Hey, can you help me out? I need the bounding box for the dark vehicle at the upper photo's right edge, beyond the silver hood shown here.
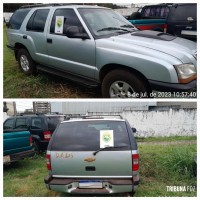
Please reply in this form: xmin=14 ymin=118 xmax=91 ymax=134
xmin=167 ymin=3 xmax=197 ymax=41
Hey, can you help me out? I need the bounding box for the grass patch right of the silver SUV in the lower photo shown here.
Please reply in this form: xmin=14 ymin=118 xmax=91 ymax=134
xmin=136 ymin=144 xmax=197 ymax=197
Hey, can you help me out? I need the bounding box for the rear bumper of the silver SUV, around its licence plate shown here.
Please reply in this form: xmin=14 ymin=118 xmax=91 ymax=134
xmin=44 ymin=176 xmax=139 ymax=194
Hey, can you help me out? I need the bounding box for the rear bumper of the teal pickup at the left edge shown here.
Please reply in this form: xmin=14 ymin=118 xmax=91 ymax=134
xmin=3 ymin=150 xmax=34 ymax=164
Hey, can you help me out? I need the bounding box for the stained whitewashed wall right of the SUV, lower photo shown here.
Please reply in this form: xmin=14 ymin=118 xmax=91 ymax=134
xmin=122 ymin=108 xmax=197 ymax=137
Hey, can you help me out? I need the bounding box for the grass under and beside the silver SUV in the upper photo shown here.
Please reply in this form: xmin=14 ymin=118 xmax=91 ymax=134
xmin=3 ymin=26 xmax=101 ymax=98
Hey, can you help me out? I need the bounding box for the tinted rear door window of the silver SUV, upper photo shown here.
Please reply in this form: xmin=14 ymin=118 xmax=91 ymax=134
xmin=26 ymin=9 xmax=49 ymax=32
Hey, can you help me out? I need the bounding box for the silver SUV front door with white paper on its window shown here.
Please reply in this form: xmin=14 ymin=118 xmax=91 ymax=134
xmin=47 ymin=8 xmax=96 ymax=78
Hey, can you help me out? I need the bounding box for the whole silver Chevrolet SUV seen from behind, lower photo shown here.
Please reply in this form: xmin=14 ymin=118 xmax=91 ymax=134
xmin=44 ymin=118 xmax=139 ymax=194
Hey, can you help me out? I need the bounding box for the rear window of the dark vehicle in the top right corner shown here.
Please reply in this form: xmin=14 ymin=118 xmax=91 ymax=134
xmin=168 ymin=4 xmax=197 ymax=21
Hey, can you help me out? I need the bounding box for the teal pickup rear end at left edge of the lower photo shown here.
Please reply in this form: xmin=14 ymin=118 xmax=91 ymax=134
xmin=3 ymin=131 xmax=34 ymax=164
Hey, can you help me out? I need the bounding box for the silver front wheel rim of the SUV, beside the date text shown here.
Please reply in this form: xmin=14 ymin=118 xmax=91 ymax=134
xmin=109 ymin=81 xmax=135 ymax=98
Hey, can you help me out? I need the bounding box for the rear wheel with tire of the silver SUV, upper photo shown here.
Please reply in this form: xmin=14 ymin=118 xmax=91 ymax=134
xmin=17 ymin=49 xmax=36 ymax=75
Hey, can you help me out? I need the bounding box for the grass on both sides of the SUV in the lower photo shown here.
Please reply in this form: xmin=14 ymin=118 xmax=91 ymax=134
xmin=3 ymin=140 xmax=197 ymax=197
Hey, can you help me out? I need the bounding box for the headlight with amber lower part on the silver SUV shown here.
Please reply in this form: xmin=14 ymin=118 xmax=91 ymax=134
xmin=174 ymin=64 xmax=197 ymax=83
